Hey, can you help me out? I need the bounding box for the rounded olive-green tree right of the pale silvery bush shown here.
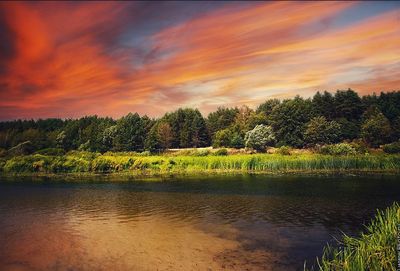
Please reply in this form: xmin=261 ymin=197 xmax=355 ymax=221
xmin=304 ymin=117 xmax=340 ymax=145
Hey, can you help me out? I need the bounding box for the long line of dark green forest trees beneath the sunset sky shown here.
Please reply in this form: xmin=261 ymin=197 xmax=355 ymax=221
xmin=0 ymin=89 xmax=400 ymax=152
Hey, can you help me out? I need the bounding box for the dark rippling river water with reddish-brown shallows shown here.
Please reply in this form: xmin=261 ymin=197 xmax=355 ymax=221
xmin=0 ymin=175 xmax=400 ymax=271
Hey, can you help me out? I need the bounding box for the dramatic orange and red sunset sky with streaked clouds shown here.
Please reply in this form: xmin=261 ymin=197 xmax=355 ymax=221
xmin=0 ymin=1 xmax=400 ymax=120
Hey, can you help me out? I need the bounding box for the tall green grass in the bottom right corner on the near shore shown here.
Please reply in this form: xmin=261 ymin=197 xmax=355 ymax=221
xmin=304 ymin=203 xmax=400 ymax=271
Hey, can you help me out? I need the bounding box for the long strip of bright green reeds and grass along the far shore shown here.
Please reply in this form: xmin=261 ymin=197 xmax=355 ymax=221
xmin=0 ymin=152 xmax=400 ymax=174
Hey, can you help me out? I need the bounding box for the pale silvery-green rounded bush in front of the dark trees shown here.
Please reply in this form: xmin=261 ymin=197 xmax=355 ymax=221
xmin=244 ymin=124 xmax=276 ymax=152
